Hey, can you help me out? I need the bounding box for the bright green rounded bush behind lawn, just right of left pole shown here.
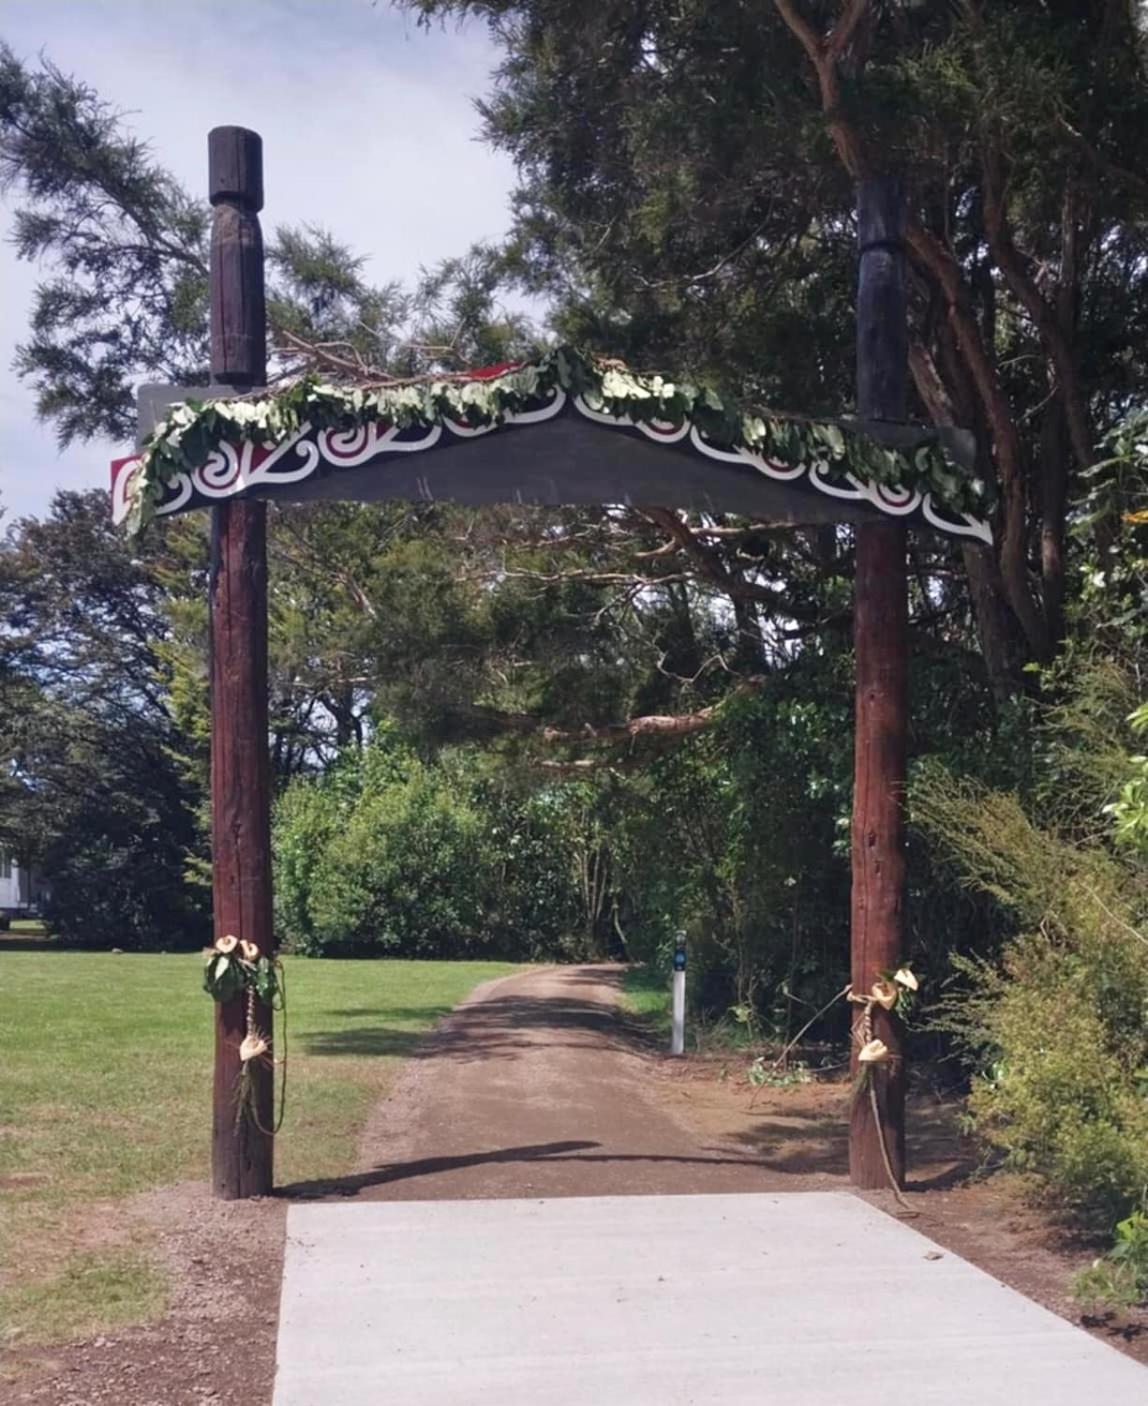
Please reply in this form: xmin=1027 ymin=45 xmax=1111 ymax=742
xmin=274 ymin=735 xmax=578 ymax=957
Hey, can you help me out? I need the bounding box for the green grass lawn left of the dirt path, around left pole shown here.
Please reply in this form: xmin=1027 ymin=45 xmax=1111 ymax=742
xmin=0 ymin=948 xmax=516 ymax=1347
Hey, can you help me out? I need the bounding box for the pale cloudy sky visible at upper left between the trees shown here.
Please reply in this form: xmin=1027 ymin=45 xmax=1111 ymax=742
xmin=0 ymin=0 xmax=514 ymax=519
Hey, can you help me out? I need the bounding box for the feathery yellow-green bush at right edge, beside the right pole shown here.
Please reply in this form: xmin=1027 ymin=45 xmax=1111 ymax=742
xmin=912 ymin=768 xmax=1148 ymax=1223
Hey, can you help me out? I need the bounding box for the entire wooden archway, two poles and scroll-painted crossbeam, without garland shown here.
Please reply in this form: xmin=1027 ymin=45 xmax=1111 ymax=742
xmin=112 ymin=127 xmax=991 ymax=1199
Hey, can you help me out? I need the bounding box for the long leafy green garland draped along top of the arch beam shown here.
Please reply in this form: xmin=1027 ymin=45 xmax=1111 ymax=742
xmin=122 ymin=347 xmax=986 ymax=530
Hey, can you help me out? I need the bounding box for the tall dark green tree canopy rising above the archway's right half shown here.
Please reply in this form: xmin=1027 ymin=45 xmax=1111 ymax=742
xmin=410 ymin=0 xmax=1148 ymax=688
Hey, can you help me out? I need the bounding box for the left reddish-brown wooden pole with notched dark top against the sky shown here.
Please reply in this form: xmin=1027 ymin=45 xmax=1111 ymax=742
xmin=208 ymin=127 xmax=274 ymax=1201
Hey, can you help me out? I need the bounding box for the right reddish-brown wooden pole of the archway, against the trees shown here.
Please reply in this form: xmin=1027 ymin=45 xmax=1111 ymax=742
xmin=849 ymin=177 xmax=909 ymax=1188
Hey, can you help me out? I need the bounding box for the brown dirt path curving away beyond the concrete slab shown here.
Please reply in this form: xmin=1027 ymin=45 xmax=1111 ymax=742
xmin=296 ymin=966 xmax=797 ymax=1201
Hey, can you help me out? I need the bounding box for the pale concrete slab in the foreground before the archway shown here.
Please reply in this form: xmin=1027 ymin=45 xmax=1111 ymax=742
xmin=274 ymin=1192 xmax=1148 ymax=1406
